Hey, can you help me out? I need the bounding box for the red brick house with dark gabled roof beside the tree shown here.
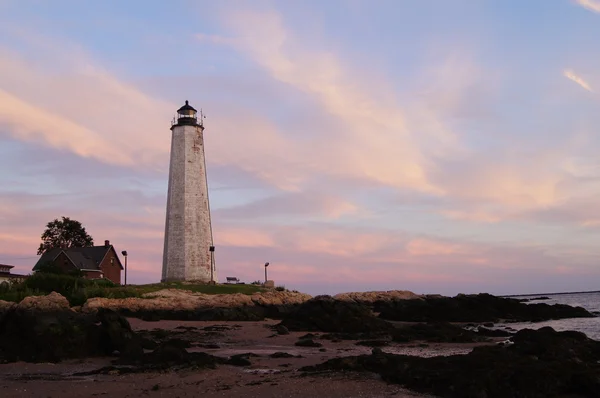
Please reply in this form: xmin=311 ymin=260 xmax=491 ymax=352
xmin=33 ymin=240 xmax=123 ymax=285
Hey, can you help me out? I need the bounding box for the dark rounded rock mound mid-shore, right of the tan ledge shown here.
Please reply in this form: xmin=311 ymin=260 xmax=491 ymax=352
xmin=280 ymin=296 xmax=393 ymax=333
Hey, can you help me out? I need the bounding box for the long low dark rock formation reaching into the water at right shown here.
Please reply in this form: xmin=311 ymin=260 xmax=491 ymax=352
xmin=379 ymin=294 xmax=594 ymax=322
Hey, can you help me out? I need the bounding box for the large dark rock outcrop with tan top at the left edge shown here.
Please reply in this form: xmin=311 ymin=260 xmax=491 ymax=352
xmin=0 ymin=293 xmax=142 ymax=362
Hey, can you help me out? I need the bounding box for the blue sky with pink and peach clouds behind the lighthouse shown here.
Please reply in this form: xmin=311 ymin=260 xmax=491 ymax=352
xmin=0 ymin=0 xmax=600 ymax=295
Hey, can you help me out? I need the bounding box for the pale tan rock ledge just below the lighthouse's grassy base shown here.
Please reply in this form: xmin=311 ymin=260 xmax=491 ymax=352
xmin=81 ymin=289 xmax=311 ymax=321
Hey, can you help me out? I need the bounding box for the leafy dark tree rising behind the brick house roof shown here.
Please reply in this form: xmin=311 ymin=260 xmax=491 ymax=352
xmin=38 ymin=216 xmax=94 ymax=254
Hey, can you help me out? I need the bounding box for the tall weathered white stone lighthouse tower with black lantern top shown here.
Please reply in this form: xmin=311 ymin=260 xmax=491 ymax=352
xmin=162 ymin=101 xmax=217 ymax=282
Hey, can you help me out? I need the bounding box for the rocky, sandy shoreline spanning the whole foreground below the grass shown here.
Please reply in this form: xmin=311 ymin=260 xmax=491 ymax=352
xmin=0 ymin=290 xmax=600 ymax=398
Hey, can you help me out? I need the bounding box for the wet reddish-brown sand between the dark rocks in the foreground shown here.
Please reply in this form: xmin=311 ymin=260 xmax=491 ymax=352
xmin=0 ymin=318 xmax=492 ymax=398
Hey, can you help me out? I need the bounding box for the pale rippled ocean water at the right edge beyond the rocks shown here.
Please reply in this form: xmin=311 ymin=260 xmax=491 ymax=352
xmin=496 ymin=292 xmax=600 ymax=340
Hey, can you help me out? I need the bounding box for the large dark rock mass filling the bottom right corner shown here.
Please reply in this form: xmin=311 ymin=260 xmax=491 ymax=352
xmin=301 ymin=327 xmax=600 ymax=398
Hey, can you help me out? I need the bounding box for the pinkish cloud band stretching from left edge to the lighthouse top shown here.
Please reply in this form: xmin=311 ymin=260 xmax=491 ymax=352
xmin=0 ymin=43 xmax=177 ymax=169
